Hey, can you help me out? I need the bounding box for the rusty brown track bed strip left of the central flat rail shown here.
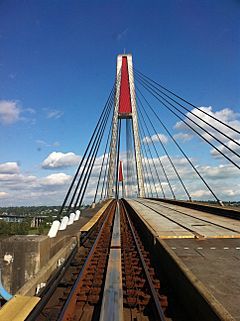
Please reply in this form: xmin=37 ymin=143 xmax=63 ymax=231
xmin=58 ymin=202 xmax=116 ymax=321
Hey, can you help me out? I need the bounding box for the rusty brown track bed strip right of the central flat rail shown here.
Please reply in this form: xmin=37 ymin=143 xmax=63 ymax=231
xmin=120 ymin=202 xmax=168 ymax=321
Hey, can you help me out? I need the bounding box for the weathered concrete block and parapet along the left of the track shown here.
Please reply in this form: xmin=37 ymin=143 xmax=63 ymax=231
xmin=0 ymin=202 xmax=107 ymax=294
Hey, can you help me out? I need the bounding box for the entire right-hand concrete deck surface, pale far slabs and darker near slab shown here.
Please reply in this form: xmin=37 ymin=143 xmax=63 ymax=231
xmin=128 ymin=199 xmax=240 ymax=321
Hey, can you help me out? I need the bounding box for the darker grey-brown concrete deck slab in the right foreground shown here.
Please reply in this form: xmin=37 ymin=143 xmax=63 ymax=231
xmin=165 ymin=239 xmax=240 ymax=321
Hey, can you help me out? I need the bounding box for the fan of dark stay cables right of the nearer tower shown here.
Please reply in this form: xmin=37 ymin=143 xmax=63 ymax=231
xmin=131 ymin=68 xmax=240 ymax=204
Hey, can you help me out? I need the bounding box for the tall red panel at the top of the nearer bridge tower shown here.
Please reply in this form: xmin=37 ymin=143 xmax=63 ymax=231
xmin=119 ymin=56 xmax=132 ymax=114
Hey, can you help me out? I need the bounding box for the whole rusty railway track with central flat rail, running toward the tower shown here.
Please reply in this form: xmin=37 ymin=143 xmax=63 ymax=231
xmin=27 ymin=200 xmax=174 ymax=321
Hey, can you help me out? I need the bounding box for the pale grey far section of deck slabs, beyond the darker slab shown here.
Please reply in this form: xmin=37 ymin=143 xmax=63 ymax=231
xmin=128 ymin=199 xmax=240 ymax=239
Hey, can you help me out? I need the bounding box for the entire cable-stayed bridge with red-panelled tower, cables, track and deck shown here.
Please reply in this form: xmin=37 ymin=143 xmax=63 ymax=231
xmin=0 ymin=54 xmax=240 ymax=321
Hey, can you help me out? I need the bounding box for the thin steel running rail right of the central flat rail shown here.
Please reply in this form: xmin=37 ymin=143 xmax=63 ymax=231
xmin=121 ymin=201 xmax=166 ymax=321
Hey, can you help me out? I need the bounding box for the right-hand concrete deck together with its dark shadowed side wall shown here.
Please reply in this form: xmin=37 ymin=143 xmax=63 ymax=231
xmin=125 ymin=200 xmax=240 ymax=321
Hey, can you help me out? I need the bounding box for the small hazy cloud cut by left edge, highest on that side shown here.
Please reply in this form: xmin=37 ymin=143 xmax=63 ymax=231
xmin=0 ymin=100 xmax=21 ymax=125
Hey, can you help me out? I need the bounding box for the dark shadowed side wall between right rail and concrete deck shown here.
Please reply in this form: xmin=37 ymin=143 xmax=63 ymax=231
xmin=124 ymin=203 xmax=234 ymax=321
